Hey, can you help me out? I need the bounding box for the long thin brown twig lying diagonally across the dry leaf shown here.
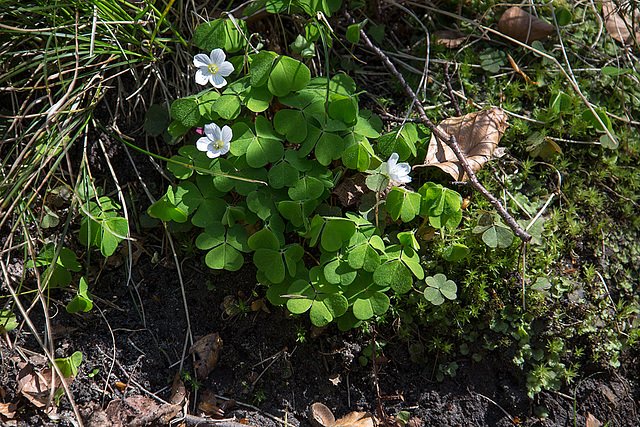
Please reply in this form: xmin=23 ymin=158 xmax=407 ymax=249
xmin=344 ymin=11 xmax=531 ymax=242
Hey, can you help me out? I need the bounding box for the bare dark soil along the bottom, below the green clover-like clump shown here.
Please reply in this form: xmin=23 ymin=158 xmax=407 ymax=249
xmin=1 ymin=252 xmax=640 ymax=427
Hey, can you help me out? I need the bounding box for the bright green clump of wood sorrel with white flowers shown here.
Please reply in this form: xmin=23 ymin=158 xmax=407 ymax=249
xmin=149 ymin=16 xmax=468 ymax=329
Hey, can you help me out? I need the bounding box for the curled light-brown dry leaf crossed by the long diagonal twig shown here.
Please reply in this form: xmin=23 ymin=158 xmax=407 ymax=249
xmin=424 ymin=107 xmax=508 ymax=181
